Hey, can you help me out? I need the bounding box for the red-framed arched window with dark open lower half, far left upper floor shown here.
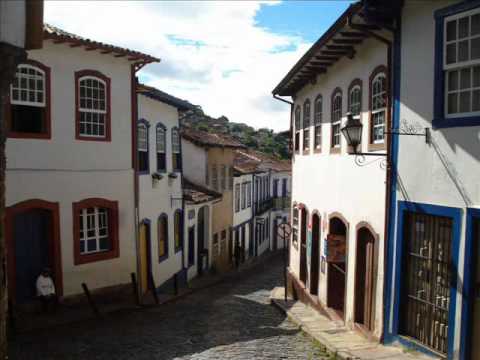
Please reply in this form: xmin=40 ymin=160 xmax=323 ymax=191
xmin=7 ymin=60 xmax=51 ymax=139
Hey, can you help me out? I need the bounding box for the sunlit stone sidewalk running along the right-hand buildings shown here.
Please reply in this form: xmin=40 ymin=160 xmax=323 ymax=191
xmin=270 ymin=287 xmax=436 ymax=360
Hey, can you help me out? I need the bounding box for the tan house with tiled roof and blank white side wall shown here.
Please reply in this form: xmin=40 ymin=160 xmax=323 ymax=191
xmin=182 ymin=129 xmax=245 ymax=271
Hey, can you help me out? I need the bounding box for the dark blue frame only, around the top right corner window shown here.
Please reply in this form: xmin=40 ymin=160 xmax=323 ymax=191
xmin=432 ymin=0 xmax=480 ymax=129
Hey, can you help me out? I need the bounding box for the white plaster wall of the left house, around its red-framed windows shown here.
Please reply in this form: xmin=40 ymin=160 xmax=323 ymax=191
xmin=6 ymin=41 xmax=136 ymax=296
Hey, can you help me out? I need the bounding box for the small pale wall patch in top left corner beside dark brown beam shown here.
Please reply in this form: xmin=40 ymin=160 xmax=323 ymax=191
xmin=0 ymin=0 xmax=26 ymax=48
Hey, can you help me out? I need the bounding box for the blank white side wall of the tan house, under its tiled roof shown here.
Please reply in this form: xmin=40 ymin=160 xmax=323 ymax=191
xmin=182 ymin=138 xmax=207 ymax=185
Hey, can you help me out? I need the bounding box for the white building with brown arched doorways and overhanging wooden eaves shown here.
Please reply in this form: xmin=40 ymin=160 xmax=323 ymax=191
xmin=273 ymin=3 xmax=389 ymax=339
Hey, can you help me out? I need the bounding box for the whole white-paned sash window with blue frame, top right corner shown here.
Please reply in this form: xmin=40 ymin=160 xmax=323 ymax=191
xmin=432 ymin=0 xmax=480 ymax=128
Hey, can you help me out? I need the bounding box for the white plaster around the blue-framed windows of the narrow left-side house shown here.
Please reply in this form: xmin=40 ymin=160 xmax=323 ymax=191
xmin=138 ymin=95 xmax=188 ymax=286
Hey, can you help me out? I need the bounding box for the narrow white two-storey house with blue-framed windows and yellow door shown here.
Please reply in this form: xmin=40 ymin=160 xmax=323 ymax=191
xmin=137 ymin=85 xmax=192 ymax=294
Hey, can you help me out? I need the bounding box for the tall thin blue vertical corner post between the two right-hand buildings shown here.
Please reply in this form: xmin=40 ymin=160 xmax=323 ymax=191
xmin=383 ymin=11 xmax=402 ymax=342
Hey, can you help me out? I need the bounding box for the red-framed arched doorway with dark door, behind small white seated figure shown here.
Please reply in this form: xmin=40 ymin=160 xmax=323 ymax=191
xmin=5 ymin=199 xmax=63 ymax=304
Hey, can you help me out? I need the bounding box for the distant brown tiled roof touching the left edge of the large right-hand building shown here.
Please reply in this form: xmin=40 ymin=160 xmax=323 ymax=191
xmin=233 ymin=149 xmax=292 ymax=174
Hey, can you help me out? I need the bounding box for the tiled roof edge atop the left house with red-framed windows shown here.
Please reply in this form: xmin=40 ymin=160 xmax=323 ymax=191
xmin=43 ymin=24 xmax=160 ymax=64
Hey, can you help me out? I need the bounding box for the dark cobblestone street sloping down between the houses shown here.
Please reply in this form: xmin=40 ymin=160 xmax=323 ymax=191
xmin=10 ymin=257 xmax=328 ymax=359
